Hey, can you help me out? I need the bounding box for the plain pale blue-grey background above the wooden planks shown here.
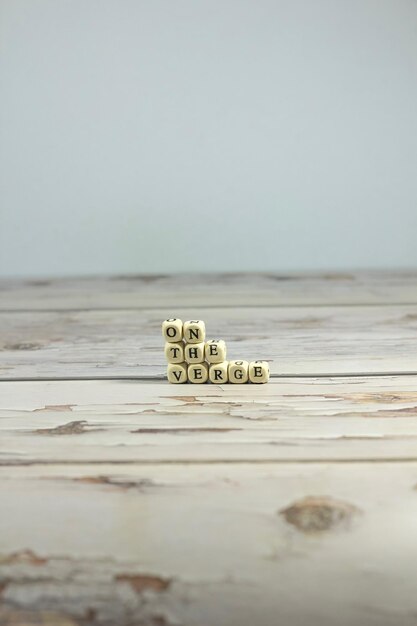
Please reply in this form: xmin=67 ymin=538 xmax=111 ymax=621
xmin=0 ymin=0 xmax=417 ymax=275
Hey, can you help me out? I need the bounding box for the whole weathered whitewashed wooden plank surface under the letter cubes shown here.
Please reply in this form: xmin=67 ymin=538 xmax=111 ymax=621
xmin=0 ymin=272 xmax=417 ymax=626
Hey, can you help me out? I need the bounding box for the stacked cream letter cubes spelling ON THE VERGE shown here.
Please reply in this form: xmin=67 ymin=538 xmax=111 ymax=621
xmin=162 ymin=318 xmax=269 ymax=384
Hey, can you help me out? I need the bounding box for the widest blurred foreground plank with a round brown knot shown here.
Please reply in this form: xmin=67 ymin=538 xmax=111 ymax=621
xmin=0 ymin=463 xmax=417 ymax=626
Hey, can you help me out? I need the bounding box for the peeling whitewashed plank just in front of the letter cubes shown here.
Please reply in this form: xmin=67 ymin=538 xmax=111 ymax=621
xmin=0 ymin=376 xmax=417 ymax=464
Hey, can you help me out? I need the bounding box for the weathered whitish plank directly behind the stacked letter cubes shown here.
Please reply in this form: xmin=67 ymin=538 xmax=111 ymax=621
xmin=0 ymin=305 xmax=417 ymax=379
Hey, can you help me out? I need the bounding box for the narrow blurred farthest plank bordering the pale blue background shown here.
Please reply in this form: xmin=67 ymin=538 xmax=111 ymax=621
xmin=0 ymin=271 xmax=417 ymax=310
